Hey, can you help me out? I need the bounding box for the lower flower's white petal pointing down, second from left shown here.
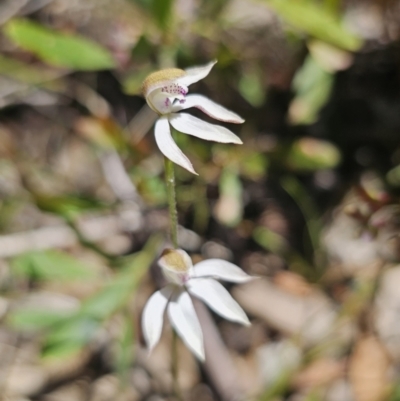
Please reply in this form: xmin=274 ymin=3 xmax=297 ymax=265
xmin=168 ymin=291 xmax=205 ymax=361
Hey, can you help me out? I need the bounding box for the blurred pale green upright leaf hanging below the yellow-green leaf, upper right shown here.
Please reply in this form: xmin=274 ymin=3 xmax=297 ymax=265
xmin=289 ymin=56 xmax=333 ymax=124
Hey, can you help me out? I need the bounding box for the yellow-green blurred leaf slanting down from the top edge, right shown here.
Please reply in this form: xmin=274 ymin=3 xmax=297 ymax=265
xmin=263 ymin=0 xmax=362 ymax=51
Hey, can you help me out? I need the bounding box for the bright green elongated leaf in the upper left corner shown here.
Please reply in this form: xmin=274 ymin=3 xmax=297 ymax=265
xmin=4 ymin=19 xmax=115 ymax=70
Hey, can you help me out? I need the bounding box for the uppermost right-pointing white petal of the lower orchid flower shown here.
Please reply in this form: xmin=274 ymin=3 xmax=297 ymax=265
xmin=189 ymin=259 xmax=255 ymax=283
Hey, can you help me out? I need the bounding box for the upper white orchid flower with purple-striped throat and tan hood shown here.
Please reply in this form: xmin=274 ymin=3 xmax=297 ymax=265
xmin=142 ymin=61 xmax=244 ymax=174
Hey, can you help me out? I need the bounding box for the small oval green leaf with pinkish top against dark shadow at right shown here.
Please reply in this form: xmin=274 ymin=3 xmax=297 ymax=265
xmin=286 ymin=137 xmax=340 ymax=171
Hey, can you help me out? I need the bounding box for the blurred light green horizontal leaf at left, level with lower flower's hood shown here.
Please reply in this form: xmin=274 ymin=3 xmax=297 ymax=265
xmin=11 ymin=250 xmax=94 ymax=281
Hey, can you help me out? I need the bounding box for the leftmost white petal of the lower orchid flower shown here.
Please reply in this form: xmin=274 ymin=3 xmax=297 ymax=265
xmin=142 ymin=286 xmax=173 ymax=351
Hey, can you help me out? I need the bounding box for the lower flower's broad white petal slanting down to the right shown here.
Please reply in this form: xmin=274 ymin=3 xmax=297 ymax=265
xmin=187 ymin=278 xmax=250 ymax=326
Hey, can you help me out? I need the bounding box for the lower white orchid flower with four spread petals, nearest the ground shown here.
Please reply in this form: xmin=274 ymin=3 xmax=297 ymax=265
xmin=142 ymin=249 xmax=254 ymax=361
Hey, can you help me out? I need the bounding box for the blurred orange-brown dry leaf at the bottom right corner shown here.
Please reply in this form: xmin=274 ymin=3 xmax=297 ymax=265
xmin=349 ymin=335 xmax=390 ymax=401
